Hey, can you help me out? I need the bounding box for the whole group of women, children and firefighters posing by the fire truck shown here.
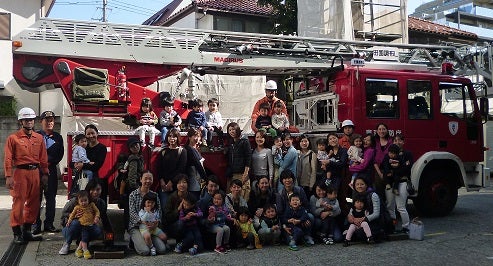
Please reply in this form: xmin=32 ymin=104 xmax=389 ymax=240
xmin=5 ymin=81 xmax=413 ymax=259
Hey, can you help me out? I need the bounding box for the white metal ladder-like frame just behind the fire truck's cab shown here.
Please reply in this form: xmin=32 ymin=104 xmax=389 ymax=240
xmin=293 ymin=92 xmax=339 ymax=132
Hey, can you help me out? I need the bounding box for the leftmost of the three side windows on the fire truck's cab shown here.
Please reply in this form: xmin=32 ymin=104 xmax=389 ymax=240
xmin=366 ymin=79 xmax=399 ymax=118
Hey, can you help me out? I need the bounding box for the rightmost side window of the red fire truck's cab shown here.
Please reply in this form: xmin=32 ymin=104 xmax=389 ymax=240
xmin=439 ymin=82 xmax=474 ymax=119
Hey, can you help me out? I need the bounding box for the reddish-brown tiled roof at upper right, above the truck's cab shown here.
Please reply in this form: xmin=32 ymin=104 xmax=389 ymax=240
xmin=408 ymin=16 xmax=478 ymax=39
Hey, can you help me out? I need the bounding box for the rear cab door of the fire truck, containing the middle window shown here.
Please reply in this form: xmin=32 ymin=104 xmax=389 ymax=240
xmin=401 ymin=79 xmax=438 ymax=158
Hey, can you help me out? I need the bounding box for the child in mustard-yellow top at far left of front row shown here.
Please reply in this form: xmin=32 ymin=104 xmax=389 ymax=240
xmin=66 ymin=190 xmax=100 ymax=259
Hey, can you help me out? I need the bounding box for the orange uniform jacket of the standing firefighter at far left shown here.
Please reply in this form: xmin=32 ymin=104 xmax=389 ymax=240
xmin=3 ymin=129 xmax=48 ymax=177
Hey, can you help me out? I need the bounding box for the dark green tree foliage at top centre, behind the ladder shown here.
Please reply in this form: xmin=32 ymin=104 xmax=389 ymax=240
xmin=258 ymin=0 xmax=298 ymax=35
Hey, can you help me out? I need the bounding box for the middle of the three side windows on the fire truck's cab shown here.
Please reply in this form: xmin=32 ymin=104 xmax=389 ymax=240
xmin=407 ymin=80 xmax=432 ymax=120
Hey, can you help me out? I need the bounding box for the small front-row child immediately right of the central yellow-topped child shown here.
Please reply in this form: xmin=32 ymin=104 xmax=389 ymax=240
xmin=254 ymin=204 xmax=281 ymax=245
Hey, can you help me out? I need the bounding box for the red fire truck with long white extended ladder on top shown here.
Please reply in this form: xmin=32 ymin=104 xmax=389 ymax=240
xmin=13 ymin=19 xmax=488 ymax=218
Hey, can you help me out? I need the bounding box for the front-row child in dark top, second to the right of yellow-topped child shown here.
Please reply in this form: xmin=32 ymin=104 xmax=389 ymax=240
xmin=282 ymin=193 xmax=315 ymax=251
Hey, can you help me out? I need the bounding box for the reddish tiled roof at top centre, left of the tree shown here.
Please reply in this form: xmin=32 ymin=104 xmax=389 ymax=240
xmin=195 ymin=0 xmax=273 ymax=15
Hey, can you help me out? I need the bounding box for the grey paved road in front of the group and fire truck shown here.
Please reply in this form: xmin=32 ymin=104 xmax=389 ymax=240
xmin=0 ymin=182 xmax=493 ymax=266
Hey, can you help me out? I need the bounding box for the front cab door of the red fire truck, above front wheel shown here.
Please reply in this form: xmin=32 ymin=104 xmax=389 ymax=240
xmin=435 ymin=82 xmax=483 ymax=162
